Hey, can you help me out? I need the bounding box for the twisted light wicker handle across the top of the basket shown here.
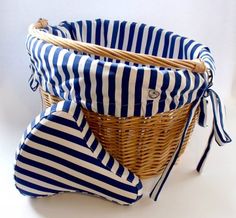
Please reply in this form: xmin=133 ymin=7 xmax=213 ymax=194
xmin=29 ymin=19 xmax=206 ymax=73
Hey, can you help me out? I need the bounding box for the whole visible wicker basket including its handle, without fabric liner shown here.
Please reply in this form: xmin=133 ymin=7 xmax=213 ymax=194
xmin=30 ymin=20 xmax=206 ymax=178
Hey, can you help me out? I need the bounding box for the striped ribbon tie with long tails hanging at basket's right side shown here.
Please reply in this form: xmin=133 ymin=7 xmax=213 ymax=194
xmin=150 ymin=88 xmax=231 ymax=201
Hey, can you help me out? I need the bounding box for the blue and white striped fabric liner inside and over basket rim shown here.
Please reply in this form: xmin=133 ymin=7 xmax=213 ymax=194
xmin=27 ymin=19 xmax=215 ymax=117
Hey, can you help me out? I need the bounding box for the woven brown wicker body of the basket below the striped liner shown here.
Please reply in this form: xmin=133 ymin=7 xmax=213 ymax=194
xmin=40 ymin=89 xmax=199 ymax=178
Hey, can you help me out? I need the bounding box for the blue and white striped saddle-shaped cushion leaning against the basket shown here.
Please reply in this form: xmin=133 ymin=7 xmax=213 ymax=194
xmin=15 ymin=101 xmax=142 ymax=204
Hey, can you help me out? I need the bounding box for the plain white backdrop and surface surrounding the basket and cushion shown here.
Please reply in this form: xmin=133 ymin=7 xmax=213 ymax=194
xmin=0 ymin=0 xmax=236 ymax=218
